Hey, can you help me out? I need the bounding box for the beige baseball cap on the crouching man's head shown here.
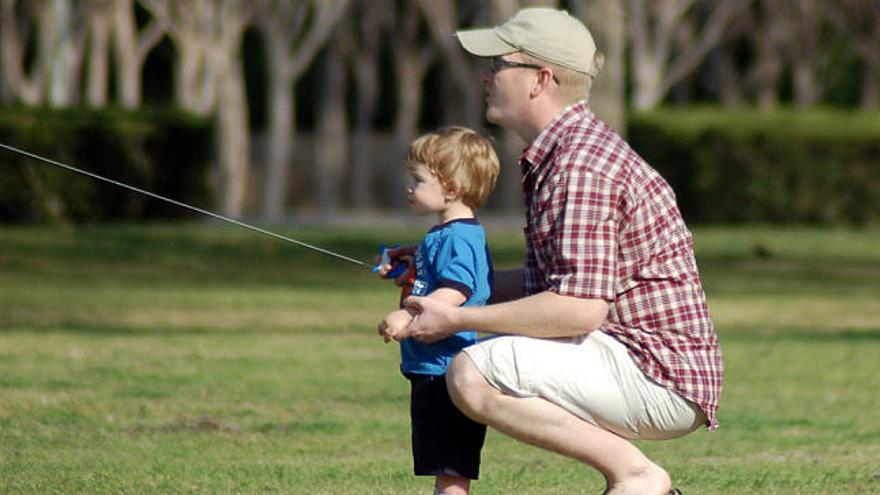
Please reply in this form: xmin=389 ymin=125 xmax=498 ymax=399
xmin=455 ymin=7 xmax=599 ymax=76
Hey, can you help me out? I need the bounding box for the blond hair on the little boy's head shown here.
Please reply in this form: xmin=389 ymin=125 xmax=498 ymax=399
xmin=406 ymin=126 xmax=500 ymax=210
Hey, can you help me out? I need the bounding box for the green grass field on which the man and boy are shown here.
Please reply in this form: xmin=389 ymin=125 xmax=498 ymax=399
xmin=0 ymin=223 xmax=880 ymax=495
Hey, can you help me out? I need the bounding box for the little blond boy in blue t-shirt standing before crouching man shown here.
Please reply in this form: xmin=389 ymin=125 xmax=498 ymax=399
xmin=379 ymin=127 xmax=499 ymax=495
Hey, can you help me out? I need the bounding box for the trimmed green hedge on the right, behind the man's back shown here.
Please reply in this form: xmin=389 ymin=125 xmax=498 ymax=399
xmin=628 ymin=108 xmax=880 ymax=225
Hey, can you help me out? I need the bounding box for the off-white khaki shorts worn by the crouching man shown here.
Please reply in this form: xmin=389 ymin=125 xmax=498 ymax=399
xmin=464 ymin=331 xmax=706 ymax=439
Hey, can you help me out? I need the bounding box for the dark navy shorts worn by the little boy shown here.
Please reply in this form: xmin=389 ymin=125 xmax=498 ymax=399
xmin=406 ymin=374 xmax=486 ymax=480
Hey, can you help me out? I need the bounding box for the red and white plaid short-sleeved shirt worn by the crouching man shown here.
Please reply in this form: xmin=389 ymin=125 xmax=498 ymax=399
xmin=520 ymin=102 xmax=723 ymax=429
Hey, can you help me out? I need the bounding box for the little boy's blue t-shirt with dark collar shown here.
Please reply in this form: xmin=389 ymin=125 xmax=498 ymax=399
xmin=400 ymin=218 xmax=492 ymax=375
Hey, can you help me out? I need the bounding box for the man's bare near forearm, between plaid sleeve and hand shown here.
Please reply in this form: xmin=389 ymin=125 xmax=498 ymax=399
xmin=458 ymin=292 xmax=609 ymax=337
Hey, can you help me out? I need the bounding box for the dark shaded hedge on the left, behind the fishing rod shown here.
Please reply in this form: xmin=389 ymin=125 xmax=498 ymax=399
xmin=0 ymin=108 xmax=213 ymax=222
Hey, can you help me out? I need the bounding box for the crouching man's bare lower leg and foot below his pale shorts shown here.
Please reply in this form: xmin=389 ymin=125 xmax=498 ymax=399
xmin=446 ymin=353 xmax=671 ymax=495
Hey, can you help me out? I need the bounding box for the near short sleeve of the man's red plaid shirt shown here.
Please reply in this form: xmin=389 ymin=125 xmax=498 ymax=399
xmin=545 ymin=157 xmax=618 ymax=302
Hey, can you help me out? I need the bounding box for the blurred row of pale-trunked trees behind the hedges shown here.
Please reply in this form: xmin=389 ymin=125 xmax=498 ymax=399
xmin=0 ymin=0 xmax=880 ymax=222
